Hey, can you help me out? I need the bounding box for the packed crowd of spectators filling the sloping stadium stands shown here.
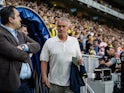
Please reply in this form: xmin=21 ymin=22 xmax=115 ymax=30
xmin=6 ymin=0 xmax=124 ymax=68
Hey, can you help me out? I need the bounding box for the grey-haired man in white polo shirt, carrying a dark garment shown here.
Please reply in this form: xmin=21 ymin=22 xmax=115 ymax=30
xmin=40 ymin=18 xmax=82 ymax=93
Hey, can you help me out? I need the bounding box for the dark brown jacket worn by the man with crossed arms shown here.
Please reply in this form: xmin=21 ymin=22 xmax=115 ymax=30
xmin=0 ymin=26 xmax=40 ymax=92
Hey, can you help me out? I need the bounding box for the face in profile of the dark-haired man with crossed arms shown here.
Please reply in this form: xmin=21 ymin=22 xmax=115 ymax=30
xmin=12 ymin=9 xmax=21 ymax=29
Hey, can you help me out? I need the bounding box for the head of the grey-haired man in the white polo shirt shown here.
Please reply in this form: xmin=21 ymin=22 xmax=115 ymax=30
xmin=57 ymin=20 xmax=69 ymax=36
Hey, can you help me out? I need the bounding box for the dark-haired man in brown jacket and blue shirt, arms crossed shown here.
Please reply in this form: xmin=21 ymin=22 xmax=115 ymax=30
xmin=0 ymin=6 xmax=40 ymax=93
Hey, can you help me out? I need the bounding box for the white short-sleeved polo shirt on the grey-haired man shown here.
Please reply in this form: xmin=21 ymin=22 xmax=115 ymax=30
xmin=40 ymin=36 xmax=82 ymax=86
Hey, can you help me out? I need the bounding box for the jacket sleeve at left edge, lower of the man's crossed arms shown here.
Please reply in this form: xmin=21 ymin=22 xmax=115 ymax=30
xmin=0 ymin=33 xmax=28 ymax=61
